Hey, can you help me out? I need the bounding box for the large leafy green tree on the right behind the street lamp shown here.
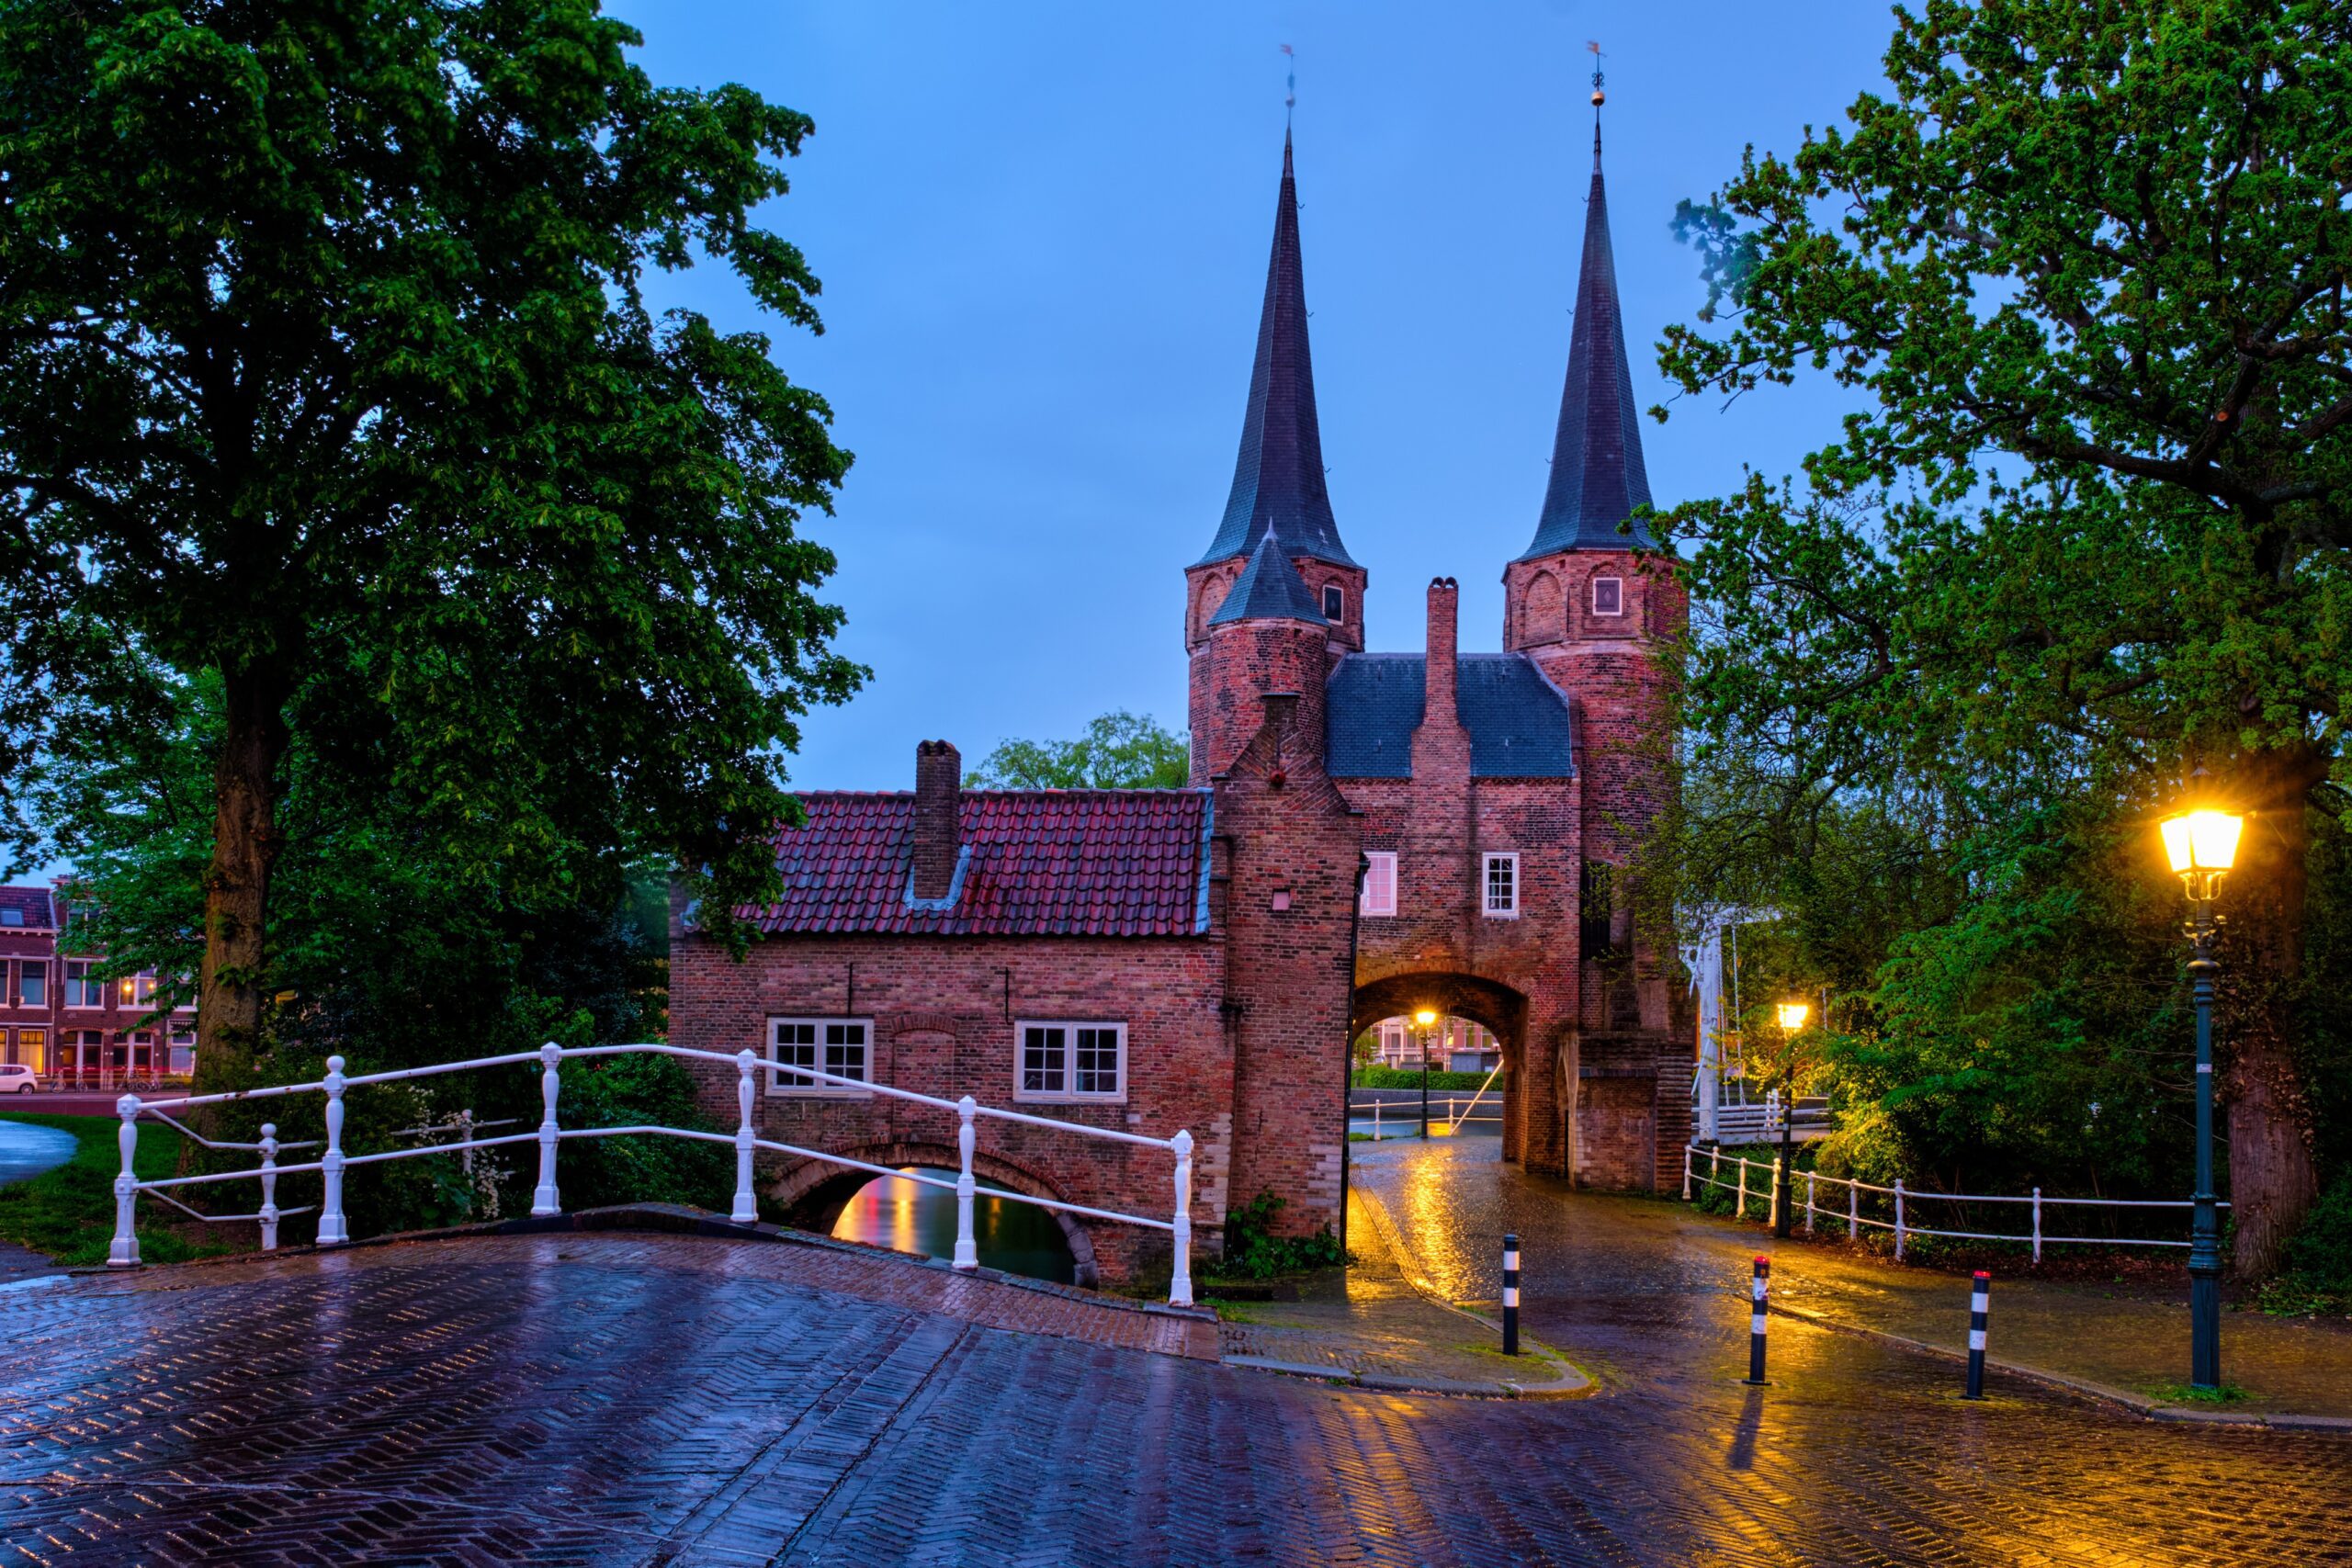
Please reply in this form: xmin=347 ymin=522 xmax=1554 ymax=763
xmin=1663 ymin=0 xmax=2352 ymax=1269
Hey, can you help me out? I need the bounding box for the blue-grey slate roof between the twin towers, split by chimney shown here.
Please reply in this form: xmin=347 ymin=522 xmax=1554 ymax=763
xmin=1324 ymin=653 xmax=1576 ymax=778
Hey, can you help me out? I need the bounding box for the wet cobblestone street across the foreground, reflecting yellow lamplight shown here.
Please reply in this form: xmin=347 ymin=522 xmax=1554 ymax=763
xmin=0 ymin=1203 xmax=2352 ymax=1568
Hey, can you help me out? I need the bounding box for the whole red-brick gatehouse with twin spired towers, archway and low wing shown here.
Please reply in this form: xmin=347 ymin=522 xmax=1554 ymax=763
xmin=671 ymin=122 xmax=1691 ymax=1277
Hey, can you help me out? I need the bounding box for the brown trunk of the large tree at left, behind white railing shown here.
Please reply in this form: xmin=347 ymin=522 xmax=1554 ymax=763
xmin=195 ymin=665 xmax=287 ymax=1093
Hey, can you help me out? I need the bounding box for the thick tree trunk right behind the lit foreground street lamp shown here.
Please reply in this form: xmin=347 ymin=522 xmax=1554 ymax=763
xmin=2216 ymin=748 xmax=2326 ymax=1279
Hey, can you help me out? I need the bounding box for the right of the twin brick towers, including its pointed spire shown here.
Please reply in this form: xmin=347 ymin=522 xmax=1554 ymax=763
xmin=1503 ymin=125 xmax=1687 ymax=1030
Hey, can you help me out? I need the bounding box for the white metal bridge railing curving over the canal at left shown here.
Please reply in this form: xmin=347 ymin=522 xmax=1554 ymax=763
xmin=106 ymin=1043 xmax=1193 ymax=1307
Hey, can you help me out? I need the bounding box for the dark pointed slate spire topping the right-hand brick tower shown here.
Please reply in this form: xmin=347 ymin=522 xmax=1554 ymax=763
xmin=1520 ymin=125 xmax=1654 ymax=559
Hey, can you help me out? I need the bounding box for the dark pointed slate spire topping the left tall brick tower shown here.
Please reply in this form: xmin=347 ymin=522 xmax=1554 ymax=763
xmin=1194 ymin=131 xmax=1355 ymax=567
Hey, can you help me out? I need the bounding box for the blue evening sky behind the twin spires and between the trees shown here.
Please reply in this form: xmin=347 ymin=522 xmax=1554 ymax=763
xmin=614 ymin=0 xmax=1894 ymax=790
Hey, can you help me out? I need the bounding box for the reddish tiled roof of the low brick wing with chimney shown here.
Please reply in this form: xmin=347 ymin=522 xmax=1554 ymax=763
xmin=736 ymin=790 xmax=1211 ymax=936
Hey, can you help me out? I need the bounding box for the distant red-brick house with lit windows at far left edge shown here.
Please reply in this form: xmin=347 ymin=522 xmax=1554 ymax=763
xmin=0 ymin=884 xmax=195 ymax=1086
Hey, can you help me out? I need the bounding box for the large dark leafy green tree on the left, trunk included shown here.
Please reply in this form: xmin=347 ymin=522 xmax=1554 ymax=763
xmin=0 ymin=0 xmax=861 ymax=1081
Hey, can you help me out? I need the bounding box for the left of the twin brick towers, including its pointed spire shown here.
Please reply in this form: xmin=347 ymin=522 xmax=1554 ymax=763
xmin=1183 ymin=131 xmax=1364 ymax=785
